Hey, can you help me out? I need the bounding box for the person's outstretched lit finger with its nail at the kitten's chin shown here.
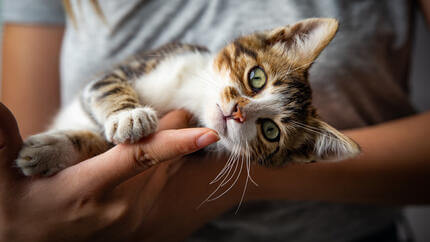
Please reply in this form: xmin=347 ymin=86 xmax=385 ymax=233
xmin=69 ymin=128 xmax=219 ymax=191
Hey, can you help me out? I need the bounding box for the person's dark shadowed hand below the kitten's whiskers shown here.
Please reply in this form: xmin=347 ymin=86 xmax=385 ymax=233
xmin=134 ymin=152 xmax=244 ymax=241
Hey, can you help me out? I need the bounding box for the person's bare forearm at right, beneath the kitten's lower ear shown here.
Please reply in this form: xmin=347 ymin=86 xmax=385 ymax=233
xmin=249 ymin=113 xmax=430 ymax=205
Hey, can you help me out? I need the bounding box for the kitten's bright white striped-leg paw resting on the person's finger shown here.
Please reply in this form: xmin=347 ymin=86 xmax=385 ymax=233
xmin=105 ymin=107 xmax=158 ymax=144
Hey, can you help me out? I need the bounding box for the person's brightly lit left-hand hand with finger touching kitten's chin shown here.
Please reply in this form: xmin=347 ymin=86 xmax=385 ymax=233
xmin=0 ymin=104 xmax=218 ymax=241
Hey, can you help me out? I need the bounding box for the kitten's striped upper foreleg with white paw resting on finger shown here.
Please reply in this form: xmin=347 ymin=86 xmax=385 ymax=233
xmin=81 ymin=72 xmax=158 ymax=143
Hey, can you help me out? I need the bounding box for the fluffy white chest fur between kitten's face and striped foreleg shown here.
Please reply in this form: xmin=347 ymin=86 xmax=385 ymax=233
xmin=134 ymin=53 xmax=213 ymax=116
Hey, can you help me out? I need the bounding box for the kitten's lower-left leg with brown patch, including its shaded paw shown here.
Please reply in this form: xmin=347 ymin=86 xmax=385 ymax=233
xmin=16 ymin=130 xmax=111 ymax=176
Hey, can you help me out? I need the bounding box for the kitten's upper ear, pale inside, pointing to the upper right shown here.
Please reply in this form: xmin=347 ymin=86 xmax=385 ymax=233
xmin=267 ymin=18 xmax=339 ymax=68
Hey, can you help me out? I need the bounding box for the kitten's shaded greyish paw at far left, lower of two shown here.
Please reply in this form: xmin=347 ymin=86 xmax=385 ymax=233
xmin=15 ymin=133 xmax=76 ymax=176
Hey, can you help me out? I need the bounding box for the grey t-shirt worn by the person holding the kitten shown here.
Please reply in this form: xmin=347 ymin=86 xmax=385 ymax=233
xmin=3 ymin=0 xmax=414 ymax=241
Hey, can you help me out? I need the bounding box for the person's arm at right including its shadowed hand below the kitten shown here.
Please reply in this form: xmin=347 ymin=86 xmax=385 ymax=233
xmin=134 ymin=112 xmax=430 ymax=241
